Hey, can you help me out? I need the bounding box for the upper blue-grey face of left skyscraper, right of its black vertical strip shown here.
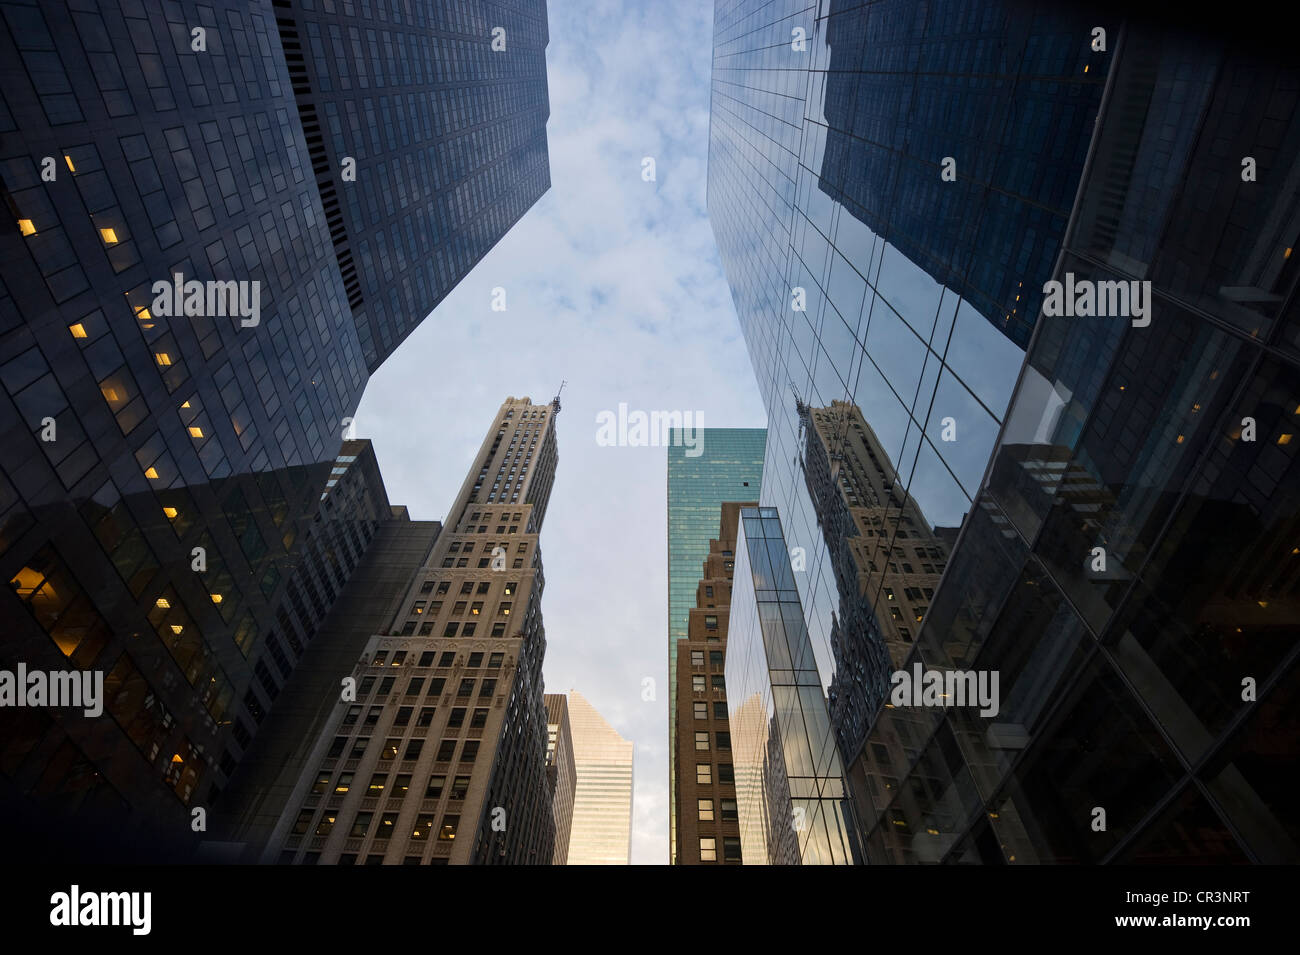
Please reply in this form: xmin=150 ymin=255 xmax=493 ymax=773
xmin=272 ymin=0 xmax=551 ymax=372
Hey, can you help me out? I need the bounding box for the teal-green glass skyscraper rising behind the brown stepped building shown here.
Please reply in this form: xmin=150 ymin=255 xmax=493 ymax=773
xmin=668 ymin=427 xmax=767 ymax=856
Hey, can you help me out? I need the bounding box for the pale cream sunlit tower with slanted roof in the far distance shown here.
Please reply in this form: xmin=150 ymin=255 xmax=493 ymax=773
xmin=568 ymin=690 xmax=634 ymax=865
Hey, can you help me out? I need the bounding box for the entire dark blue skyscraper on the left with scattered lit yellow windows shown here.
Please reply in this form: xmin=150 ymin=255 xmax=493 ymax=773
xmin=0 ymin=0 xmax=547 ymax=855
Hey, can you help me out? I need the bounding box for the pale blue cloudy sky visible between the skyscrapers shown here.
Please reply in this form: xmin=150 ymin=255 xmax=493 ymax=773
xmin=356 ymin=0 xmax=766 ymax=864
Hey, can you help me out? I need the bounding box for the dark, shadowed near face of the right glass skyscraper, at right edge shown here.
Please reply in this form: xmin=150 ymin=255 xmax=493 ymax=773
xmin=859 ymin=29 xmax=1300 ymax=864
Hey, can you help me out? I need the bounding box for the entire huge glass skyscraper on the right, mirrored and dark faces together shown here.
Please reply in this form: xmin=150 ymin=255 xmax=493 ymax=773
xmin=709 ymin=0 xmax=1300 ymax=863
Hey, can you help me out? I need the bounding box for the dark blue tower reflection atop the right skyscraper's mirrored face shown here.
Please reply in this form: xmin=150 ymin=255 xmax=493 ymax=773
xmin=803 ymin=0 xmax=1115 ymax=348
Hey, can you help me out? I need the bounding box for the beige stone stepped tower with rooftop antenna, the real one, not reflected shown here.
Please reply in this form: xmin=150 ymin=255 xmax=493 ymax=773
xmin=268 ymin=398 xmax=561 ymax=865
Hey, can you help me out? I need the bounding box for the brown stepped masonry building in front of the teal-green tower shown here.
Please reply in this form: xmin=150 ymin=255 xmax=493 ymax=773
xmin=672 ymin=504 xmax=754 ymax=865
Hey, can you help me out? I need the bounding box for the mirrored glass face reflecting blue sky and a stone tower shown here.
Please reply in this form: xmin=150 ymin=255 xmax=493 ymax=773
xmin=709 ymin=0 xmax=1113 ymax=860
